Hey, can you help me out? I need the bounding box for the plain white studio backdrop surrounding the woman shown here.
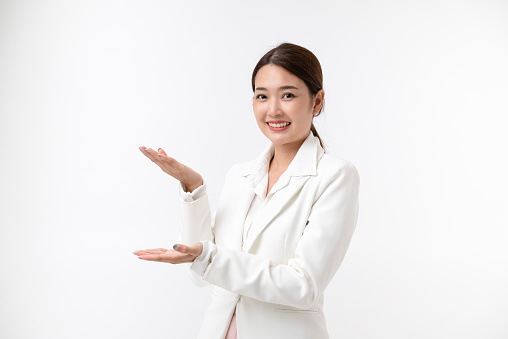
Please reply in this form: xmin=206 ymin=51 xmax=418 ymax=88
xmin=0 ymin=0 xmax=508 ymax=339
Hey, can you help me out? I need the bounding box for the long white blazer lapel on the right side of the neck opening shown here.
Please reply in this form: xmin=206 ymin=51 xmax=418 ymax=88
xmin=243 ymin=175 xmax=310 ymax=252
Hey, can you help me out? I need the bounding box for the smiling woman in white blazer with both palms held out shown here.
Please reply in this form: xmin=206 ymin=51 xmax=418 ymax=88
xmin=134 ymin=43 xmax=359 ymax=339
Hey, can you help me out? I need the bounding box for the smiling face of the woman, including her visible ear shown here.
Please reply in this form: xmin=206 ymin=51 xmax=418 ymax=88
xmin=252 ymin=64 xmax=324 ymax=147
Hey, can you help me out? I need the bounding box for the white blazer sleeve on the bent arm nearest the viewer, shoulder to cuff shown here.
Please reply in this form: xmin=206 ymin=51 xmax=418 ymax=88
xmin=196 ymin=163 xmax=359 ymax=309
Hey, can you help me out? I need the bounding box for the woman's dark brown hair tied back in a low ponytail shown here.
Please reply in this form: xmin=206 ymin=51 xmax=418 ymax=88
xmin=252 ymin=42 xmax=324 ymax=148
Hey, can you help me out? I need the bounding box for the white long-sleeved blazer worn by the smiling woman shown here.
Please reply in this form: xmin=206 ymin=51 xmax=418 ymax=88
xmin=180 ymin=133 xmax=359 ymax=339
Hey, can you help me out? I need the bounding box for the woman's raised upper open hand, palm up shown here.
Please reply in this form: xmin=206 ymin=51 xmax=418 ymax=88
xmin=139 ymin=146 xmax=203 ymax=192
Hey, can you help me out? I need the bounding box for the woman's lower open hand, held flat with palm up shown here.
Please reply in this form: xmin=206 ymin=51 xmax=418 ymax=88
xmin=134 ymin=242 xmax=203 ymax=264
